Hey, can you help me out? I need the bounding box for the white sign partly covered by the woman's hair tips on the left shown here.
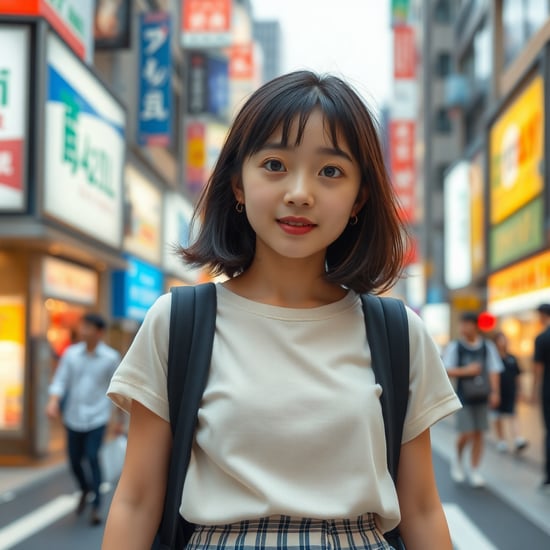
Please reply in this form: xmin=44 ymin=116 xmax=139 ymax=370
xmin=162 ymin=192 xmax=199 ymax=283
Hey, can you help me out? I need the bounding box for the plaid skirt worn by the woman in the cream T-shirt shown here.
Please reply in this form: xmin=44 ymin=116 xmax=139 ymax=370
xmin=186 ymin=514 xmax=391 ymax=550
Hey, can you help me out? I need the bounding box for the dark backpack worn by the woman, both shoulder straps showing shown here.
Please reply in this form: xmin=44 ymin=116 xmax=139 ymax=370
xmin=152 ymin=283 xmax=409 ymax=550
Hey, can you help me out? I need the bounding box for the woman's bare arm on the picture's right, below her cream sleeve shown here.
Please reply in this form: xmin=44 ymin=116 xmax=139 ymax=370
xmin=397 ymin=430 xmax=452 ymax=550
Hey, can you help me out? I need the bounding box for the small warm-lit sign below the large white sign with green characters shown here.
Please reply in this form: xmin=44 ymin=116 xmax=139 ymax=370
xmin=42 ymin=257 xmax=98 ymax=306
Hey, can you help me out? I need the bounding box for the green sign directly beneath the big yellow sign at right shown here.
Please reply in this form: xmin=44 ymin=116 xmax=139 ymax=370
xmin=489 ymin=196 xmax=544 ymax=270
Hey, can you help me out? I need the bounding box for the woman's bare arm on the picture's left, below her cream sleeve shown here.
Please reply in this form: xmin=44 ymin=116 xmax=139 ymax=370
xmin=101 ymin=401 xmax=172 ymax=550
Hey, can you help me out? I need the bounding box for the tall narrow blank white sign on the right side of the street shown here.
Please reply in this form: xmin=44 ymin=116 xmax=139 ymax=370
xmin=444 ymin=161 xmax=472 ymax=289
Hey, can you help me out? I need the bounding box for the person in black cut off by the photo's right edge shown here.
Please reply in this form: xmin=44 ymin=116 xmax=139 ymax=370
xmin=534 ymin=304 xmax=550 ymax=494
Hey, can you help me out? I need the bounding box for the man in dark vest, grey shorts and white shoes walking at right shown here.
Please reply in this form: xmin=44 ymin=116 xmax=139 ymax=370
xmin=443 ymin=312 xmax=503 ymax=487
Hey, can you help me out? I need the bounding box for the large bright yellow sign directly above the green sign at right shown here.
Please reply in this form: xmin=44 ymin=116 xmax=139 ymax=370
xmin=489 ymin=76 xmax=544 ymax=224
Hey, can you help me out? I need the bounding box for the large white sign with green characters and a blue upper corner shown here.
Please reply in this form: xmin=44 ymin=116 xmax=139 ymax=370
xmin=44 ymin=34 xmax=126 ymax=248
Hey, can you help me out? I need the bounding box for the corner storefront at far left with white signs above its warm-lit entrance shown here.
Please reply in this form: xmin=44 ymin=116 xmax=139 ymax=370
xmin=0 ymin=20 xmax=126 ymax=461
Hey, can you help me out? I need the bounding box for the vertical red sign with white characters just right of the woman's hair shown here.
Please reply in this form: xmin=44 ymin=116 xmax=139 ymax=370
xmin=390 ymin=120 xmax=416 ymax=222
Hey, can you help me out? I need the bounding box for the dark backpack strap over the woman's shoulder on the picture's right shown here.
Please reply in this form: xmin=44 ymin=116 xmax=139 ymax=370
xmin=361 ymin=294 xmax=410 ymax=549
